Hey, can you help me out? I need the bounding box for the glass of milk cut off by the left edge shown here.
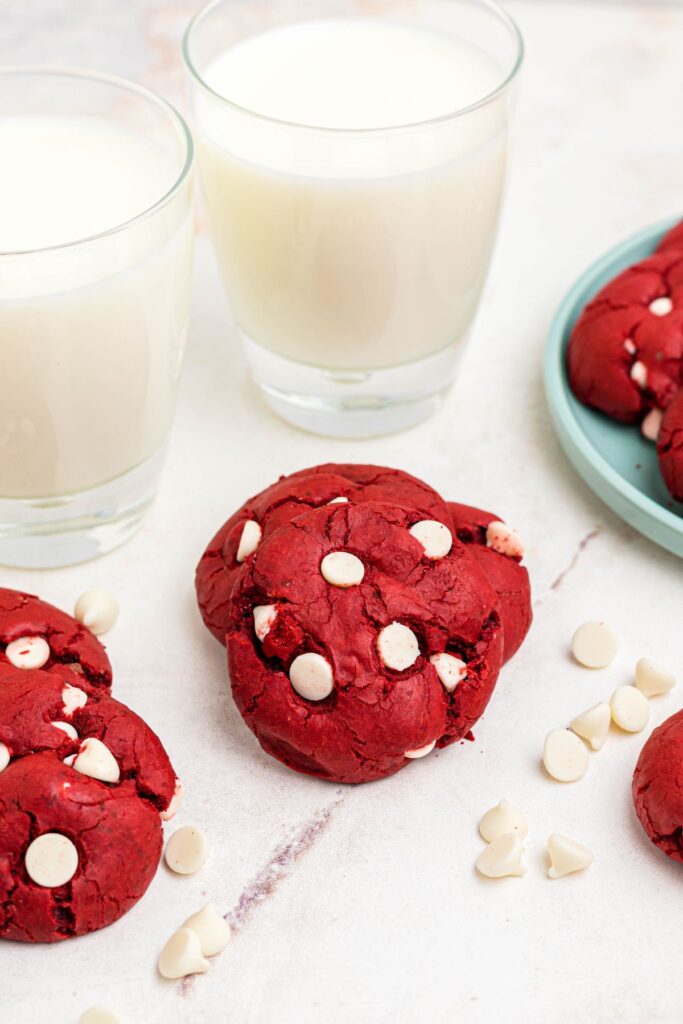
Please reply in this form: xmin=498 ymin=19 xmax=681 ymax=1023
xmin=0 ymin=68 xmax=194 ymax=567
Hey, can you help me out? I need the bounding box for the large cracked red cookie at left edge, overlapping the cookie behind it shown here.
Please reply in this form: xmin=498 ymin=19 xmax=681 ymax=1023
xmin=0 ymin=665 xmax=177 ymax=942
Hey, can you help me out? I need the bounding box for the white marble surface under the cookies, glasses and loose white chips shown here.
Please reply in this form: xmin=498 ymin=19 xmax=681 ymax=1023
xmin=0 ymin=0 xmax=683 ymax=1024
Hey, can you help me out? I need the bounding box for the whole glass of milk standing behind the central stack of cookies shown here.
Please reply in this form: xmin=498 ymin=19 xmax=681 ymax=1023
xmin=184 ymin=0 xmax=522 ymax=437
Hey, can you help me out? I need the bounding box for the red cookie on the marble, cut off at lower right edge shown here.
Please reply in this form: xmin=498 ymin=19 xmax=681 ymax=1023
xmin=633 ymin=711 xmax=683 ymax=863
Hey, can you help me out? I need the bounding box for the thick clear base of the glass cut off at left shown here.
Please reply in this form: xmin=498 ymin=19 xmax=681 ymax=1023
xmin=0 ymin=444 xmax=166 ymax=569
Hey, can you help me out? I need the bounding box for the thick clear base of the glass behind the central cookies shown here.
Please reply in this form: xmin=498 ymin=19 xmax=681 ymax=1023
xmin=242 ymin=334 xmax=464 ymax=437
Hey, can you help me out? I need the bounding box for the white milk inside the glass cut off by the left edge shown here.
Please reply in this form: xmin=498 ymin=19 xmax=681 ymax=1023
xmin=0 ymin=115 xmax=193 ymax=499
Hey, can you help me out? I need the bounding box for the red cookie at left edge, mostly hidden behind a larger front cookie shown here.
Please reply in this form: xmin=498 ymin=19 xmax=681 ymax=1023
xmin=0 ymin=588 xmax=112 ymax=692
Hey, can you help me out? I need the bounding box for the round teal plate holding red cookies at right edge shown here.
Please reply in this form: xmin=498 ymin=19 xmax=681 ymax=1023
xmin=545 ymin=221 xmax=683 ymax=558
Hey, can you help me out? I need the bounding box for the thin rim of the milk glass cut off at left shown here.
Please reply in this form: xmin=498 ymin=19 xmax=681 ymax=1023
xmin=0 ymin=65 xmax=195 ymax=259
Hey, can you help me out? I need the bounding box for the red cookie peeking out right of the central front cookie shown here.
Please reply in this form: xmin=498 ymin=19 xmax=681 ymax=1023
xmin=449 ymin=502 xmax=532 ymax=662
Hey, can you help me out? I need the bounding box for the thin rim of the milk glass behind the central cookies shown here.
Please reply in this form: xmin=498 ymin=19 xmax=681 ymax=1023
xmin=182 ymin=0 xmax=524 ymax=136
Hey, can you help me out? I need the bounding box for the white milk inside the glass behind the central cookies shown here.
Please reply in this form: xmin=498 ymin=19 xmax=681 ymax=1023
xmin=196 ymin=18 xmax=507 ymax=372
